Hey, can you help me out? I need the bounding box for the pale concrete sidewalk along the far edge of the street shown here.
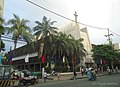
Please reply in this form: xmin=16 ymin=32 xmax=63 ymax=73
xmin=8 ymin=71 xmax=120 ymax=87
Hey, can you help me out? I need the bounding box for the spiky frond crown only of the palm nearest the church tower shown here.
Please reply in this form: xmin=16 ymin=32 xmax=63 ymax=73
xmin=33 ymin=16 xmax=57 ymax=39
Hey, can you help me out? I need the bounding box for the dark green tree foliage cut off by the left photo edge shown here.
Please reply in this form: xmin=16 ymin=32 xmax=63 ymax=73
xmin=0 ymin=17 xmax=5 ymax=52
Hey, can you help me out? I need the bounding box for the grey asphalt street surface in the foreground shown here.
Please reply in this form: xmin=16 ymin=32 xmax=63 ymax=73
xmin=25 ymin=74 xmax=120 ymax=87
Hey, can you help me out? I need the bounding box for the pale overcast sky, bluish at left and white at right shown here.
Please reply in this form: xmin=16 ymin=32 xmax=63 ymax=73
xmin=4 ymin=0 xmax=120 ymax=50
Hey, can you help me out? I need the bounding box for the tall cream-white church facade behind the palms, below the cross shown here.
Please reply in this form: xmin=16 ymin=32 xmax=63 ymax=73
xmin=59 ymin=23 xmax=93 ymax=66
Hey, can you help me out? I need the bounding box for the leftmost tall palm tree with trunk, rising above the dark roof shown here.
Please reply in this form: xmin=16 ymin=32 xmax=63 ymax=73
xmin=7 ymin=14 xmax=33 ymax=50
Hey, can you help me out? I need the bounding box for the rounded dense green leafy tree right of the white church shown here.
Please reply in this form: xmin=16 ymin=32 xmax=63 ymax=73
xmin=92 ymin=44 xmax=119 ymax=65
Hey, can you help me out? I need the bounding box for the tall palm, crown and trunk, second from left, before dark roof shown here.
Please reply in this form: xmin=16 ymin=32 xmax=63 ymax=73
xmin=33 ymin=16 xmax=58 ymax=58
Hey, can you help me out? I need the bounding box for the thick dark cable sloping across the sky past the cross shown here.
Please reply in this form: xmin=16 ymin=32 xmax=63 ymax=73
xmin=26 ymin=0 xmax=107 ymax=30
